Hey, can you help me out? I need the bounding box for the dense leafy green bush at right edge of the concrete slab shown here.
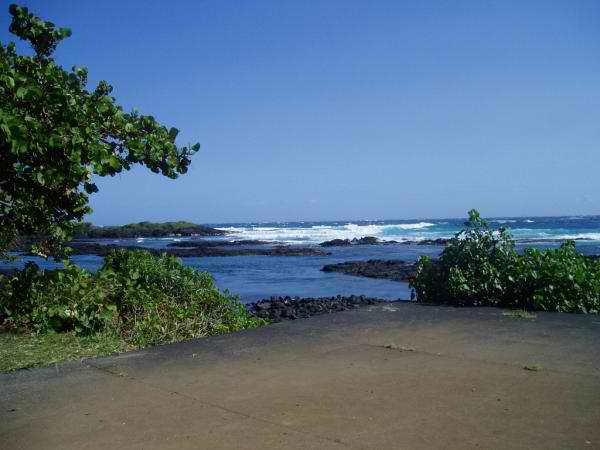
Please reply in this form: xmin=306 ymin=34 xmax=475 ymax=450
xmin=411 ymin=210 xmax=600 ymax=313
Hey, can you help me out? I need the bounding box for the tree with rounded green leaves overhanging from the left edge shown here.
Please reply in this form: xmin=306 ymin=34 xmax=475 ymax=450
xmin=0 ymin=5 xmax=200 ymax=256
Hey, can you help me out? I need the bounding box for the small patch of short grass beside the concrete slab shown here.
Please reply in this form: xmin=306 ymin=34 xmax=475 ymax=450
xmin=0 ymin=329 xmax=128 ymax=372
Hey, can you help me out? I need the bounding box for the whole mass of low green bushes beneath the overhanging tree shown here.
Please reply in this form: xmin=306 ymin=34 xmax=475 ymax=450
xmin=0 ymin=250 xmax=264 ymax=346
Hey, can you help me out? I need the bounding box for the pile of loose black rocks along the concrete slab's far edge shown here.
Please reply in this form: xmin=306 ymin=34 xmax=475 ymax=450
xmin=247 ymin=295 xmax=389 ymax=322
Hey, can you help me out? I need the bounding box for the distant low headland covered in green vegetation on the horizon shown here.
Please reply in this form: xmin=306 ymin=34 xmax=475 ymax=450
xmin=73 ymin=221 xmax=225 ymax=239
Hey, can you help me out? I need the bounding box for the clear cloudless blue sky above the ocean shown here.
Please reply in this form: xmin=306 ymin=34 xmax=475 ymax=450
xmin=0 ymin=0 xmax=600 ymax=225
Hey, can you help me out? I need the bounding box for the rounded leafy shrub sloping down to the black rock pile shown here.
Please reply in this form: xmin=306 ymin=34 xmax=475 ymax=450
xmin=101 ymin=250 xmax=264 ymax=346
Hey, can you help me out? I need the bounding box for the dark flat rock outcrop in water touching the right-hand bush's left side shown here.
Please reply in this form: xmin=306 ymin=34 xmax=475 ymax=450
xmin=321 ymin=259 xmax=417 ymax=282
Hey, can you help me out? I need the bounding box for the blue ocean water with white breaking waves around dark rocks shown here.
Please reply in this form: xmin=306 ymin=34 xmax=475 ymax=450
xmin=3 ymin=216 xmax=600 ymax=302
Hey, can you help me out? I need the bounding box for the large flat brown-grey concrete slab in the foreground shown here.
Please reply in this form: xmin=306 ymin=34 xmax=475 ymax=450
xmin=0 ymin=303 xmax=600 ymax=450
